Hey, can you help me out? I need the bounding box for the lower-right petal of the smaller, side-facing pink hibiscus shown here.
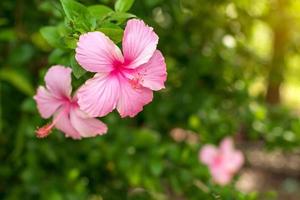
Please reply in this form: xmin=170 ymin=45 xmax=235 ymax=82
xmin=70 ymin=107 xmax=107 ymax=137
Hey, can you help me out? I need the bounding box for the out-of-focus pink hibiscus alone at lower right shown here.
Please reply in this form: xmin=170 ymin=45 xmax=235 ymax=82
xmin=199 ymin=138 xmax=244 ymax=185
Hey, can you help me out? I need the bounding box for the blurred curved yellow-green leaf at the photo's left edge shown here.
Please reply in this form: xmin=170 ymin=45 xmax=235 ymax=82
xmin=0 ymin=68 xmax=34 ymax=96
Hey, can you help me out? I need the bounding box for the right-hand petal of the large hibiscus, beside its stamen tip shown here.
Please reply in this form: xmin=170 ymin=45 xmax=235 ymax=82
xmin=137 ymin=50 xmax=167 ymax=90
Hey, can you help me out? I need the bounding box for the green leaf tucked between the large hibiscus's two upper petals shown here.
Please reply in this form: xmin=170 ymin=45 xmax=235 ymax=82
xmin=97 ymin=23 xmax=123 ymax=43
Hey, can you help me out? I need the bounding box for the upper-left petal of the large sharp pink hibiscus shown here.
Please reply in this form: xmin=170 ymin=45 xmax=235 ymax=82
xmin=75 ymin=32 xmax=123 ymax=72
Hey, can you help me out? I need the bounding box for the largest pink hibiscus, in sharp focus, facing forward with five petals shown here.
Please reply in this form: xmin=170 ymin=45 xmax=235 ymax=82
xmin=75 ymin=19 xmax=167 ymax=117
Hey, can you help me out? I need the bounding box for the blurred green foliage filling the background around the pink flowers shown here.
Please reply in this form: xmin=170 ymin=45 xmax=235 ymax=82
xmin=0 ymin=0 xmax=300 ymax=200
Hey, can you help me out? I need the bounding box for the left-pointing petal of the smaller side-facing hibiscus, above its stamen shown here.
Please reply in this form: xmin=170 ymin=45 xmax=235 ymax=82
xmin=33 ymin=86 xmax=63 ymax=118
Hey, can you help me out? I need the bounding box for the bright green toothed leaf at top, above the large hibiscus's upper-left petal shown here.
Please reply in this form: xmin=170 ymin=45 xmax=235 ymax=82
xmin=60 ymin=0 xmax=94 ymax=31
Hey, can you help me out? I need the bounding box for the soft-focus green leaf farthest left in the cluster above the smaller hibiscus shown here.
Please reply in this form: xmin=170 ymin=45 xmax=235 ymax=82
xmin=40 ymin=26 xmax=64 ymax=48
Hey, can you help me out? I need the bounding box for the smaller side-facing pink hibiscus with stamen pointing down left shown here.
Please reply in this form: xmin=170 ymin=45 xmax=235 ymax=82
xmin=34 ymin=65 xmax=107 ymax=139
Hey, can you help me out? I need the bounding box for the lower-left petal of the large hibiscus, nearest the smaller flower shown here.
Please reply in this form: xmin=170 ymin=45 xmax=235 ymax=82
xmin=77 ymin=73 xmax=120 ymax=117
